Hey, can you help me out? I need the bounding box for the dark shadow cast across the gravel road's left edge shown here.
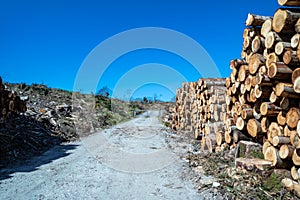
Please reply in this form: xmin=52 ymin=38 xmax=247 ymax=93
xmin=0 ymin=144 xmax=78 ymax=181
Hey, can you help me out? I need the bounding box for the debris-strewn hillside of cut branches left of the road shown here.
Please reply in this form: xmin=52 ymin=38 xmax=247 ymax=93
xmin=0 ymin=80 xmax=143 ymax=167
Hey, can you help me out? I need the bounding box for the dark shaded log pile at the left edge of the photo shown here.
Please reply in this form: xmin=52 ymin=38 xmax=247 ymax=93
xmin=0 ymin=77 xmax=28 ymax=119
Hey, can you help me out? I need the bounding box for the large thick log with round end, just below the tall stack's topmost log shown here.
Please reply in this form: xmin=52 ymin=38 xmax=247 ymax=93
xmin=272 ymin=9 xmax=300 ymax=33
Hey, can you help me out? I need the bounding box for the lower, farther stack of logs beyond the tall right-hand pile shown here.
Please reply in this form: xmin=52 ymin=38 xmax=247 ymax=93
xmin=172 ymin=78 xmax=226 ymax=152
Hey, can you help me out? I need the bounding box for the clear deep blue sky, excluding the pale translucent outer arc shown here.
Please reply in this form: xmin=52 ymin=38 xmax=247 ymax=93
xmin=0 ymin=0 xmax=279 ymax=100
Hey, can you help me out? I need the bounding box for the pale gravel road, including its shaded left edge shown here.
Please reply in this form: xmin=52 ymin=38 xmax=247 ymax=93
xmin=0 ymin=111 xmax=201 ymax=200
